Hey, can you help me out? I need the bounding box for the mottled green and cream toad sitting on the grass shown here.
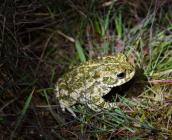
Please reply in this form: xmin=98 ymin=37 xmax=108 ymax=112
xmin=56 ymin=53 xmax=135 ymax=115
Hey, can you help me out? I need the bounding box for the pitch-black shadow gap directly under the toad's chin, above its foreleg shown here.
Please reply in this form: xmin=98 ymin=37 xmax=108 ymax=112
xmin=102 ymin=78 xmax=135 ymax=101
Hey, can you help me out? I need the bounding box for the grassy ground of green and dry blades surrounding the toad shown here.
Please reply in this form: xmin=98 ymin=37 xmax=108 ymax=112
xmin=0 ymin=0 xmax=172 ymax=140
